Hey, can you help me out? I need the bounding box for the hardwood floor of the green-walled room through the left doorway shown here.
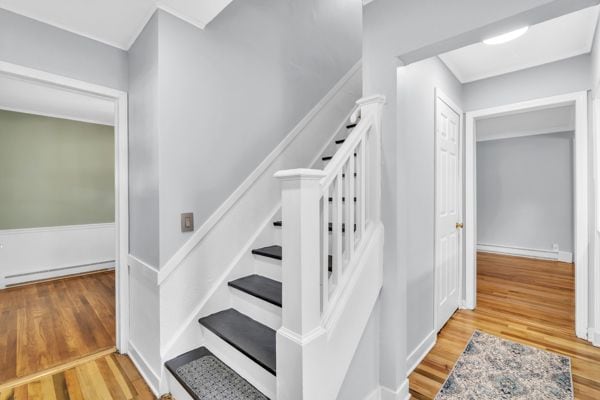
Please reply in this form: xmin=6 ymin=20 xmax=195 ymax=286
xmin=0 ymin=271 xmax=115 ymax=384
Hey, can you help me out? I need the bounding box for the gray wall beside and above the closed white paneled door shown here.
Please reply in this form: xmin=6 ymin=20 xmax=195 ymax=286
xmin=398 ymin=57 xmax=463 ymax=354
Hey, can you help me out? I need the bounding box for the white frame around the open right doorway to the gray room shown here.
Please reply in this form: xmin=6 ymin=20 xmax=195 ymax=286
xmin=464 ymin=92 xmax=589 ymax=339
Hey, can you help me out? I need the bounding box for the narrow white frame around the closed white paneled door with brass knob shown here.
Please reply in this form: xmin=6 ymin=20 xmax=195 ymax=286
xmin=433 ymin=87 xmax=464 ymax=332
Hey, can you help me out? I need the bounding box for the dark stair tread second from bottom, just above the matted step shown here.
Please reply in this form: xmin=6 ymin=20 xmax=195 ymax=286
xmin=198 ymin=308 xmax=276 ymax=375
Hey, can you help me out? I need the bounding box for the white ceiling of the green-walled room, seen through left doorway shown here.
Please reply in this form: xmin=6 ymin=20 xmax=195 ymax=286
xmin=0 ymin=75 xmax=114 ymax=125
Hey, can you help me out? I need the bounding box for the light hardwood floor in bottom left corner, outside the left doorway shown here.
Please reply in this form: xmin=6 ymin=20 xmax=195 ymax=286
xmin=0 ymin=353 xmax=156 ymax=400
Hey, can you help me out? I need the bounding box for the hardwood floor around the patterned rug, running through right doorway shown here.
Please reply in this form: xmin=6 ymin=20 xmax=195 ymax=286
xmin=409 ymin=253 xmax=600 ymax=400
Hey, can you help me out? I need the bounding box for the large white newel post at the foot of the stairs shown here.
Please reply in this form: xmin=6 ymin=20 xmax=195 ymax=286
xmin=275 ymin=169 xmax=325 ymax=400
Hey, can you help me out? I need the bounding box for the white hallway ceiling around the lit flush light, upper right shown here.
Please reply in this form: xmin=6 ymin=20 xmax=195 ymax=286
xmin=440 ymin=6 xmax=599 ymax=83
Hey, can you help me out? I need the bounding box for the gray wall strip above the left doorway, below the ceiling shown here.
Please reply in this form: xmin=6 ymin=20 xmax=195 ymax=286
xmin=0 ymin=9 xmax=127 ymax=90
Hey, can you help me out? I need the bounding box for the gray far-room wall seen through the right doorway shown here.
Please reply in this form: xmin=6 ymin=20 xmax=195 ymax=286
xmin=477 ymin=132 xmax=574 ymax=252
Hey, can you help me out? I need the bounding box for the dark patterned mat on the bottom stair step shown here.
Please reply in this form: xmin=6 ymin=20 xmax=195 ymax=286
xmin=175 ymin=348 xmax=269 ymax=400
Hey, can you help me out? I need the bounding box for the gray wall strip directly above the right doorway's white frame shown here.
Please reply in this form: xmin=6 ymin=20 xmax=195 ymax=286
xmin=464 ymin=54 xmax=591 ymax=111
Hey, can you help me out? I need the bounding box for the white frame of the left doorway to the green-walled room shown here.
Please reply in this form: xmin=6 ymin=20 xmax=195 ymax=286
xmin=0 ymin=61 xmax=129 ymax=353
